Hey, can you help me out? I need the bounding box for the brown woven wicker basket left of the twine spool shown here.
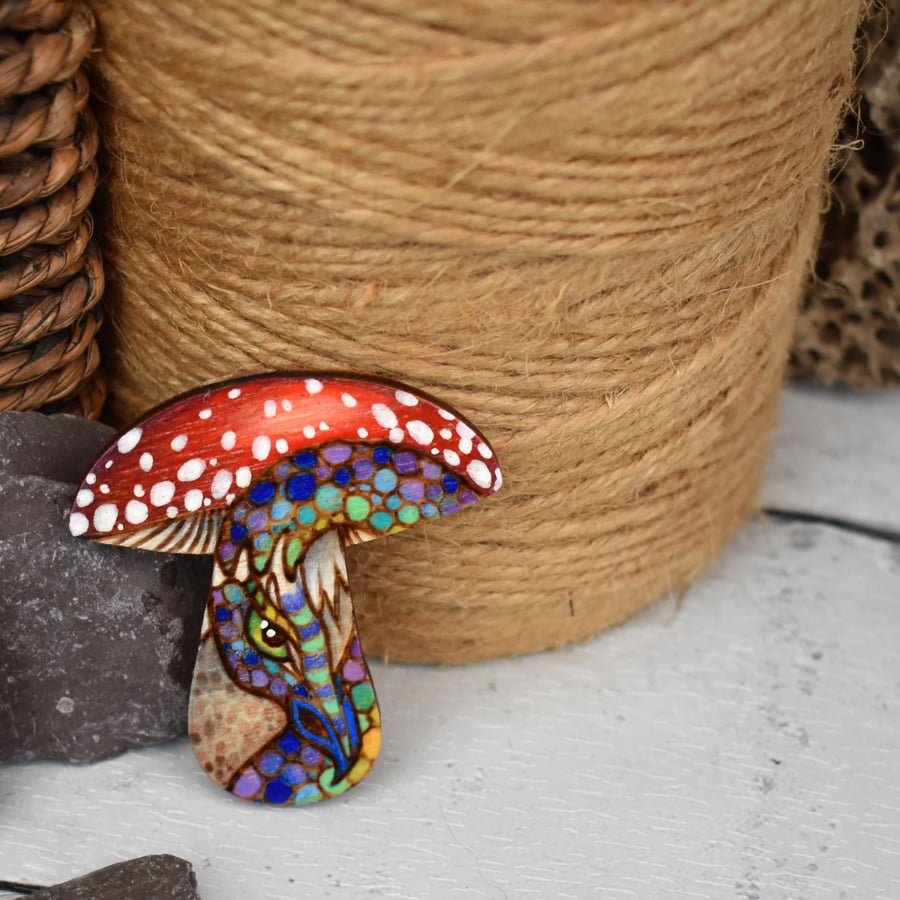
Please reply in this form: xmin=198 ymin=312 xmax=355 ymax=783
xmin=0 ymin=0 xmax=105 ymax=418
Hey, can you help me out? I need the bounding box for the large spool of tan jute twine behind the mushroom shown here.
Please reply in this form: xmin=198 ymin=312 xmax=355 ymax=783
xmin=89 ymin=0 xmax=860 ymax=662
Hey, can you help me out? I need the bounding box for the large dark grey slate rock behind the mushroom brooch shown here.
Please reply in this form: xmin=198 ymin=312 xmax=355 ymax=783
xmin=0 ymin=413 xmax=211 ymax=762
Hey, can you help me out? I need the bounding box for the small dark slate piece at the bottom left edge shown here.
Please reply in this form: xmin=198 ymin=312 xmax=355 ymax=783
xmin=25 ymin=854 xmax=200 ymax=900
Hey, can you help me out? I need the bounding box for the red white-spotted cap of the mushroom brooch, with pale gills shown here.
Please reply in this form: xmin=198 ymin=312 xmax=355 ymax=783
xmin=69 ymin=373 xmax=502 ymax=553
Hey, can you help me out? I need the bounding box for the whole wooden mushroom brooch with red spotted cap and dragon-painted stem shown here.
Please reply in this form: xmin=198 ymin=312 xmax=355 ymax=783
xmin=69 ymin=373 xmax=501 ymax=805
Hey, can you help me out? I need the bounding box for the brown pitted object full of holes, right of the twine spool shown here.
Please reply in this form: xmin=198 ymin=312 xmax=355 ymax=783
xmin=791 ymin=0 xmax=900 ymax=388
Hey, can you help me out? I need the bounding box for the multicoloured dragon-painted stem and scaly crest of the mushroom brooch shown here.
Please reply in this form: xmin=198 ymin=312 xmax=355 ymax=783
xmin=190 ymin=442 xmax=486 ymax=803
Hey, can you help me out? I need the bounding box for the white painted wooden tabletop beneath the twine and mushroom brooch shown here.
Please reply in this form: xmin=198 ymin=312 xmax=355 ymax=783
xmin=0 ymin=388 xmax=900 ymax=900
